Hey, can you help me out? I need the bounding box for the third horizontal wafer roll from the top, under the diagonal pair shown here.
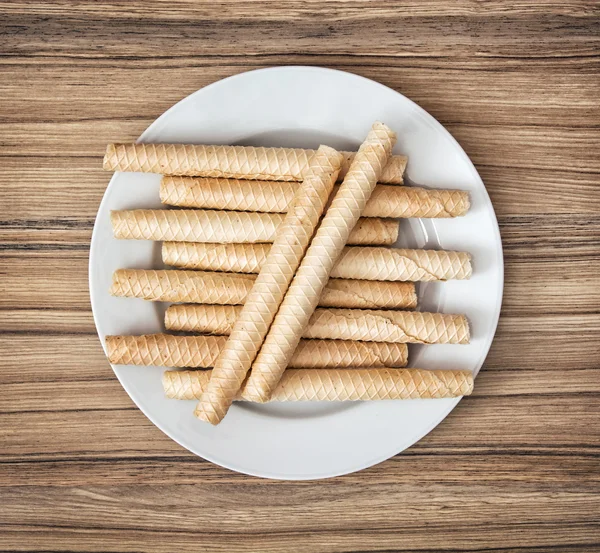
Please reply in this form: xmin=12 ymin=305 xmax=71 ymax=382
xmin=110 ymin=209 xmax=398 ymax=245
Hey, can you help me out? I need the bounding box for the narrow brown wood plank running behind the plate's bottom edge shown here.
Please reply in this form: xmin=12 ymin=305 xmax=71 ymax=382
xmin=0 ymin=449 xmax=600 ymax=491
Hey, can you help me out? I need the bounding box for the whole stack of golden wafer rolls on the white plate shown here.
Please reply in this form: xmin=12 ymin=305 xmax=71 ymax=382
xmin=104 ymin=123 xmax=473 ymax=424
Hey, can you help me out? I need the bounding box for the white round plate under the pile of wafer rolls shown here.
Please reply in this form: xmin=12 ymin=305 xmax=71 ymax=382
xmin=90 ymin=67 xmax=503 ymax=480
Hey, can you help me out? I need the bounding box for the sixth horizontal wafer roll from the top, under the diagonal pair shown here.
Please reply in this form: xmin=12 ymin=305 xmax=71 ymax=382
xmin=165 ymin=304 xmax=469 ymax=344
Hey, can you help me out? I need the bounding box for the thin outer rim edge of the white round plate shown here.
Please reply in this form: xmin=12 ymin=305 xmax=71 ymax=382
xmin=88 ymin=65 xmax=504 ymax=481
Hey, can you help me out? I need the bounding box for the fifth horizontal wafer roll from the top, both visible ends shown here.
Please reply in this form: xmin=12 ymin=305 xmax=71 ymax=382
xmin=110 ymin=269 xmax=417 ymax=309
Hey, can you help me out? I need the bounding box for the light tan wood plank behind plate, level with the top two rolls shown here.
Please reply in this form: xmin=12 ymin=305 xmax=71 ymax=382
xmin=0 ymin=156 xmax=600 ymax=220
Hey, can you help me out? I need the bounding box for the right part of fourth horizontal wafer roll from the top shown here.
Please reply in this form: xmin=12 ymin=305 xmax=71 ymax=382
xmin=332 ymin=248 xmax=472 ymax=281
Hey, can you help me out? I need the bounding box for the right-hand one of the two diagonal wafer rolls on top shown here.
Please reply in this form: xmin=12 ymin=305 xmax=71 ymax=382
xmin=245 ymin=123 xmax=396 ymax=402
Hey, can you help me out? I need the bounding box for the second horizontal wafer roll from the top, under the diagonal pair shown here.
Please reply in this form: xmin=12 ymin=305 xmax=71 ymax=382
xmin=160 ymin=176 xmax=470 ymax=218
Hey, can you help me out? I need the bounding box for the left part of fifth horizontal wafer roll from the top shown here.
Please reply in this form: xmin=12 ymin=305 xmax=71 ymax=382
xmin=110 ymin=269 xmax=256 ymax=305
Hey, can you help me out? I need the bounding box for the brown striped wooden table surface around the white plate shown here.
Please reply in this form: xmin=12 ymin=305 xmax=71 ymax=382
xmin=0 ymin=0 xmax=600 ymax=553
